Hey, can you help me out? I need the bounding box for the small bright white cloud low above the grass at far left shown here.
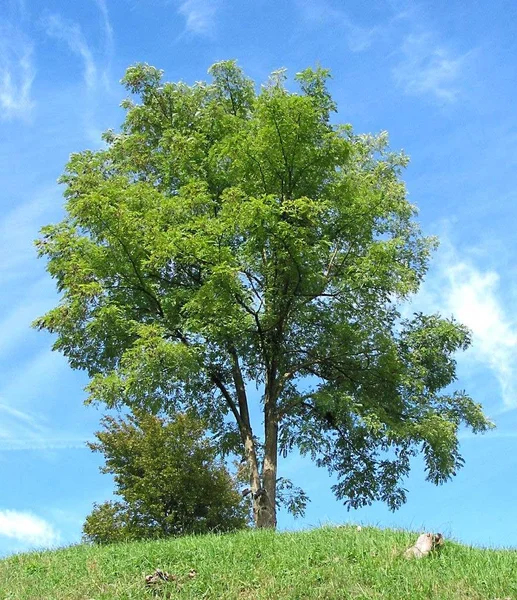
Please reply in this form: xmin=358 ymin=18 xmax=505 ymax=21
xmin=0 ymin=510 xmax=60 ymax=547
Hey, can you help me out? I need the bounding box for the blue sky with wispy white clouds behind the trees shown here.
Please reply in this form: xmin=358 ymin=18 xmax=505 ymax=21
xmin=0 ymin=0 xmax=517 ymax=555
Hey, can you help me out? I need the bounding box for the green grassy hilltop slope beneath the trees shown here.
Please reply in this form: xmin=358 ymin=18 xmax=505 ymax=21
xmin=0 ymin=526 xmax=517 ymax=600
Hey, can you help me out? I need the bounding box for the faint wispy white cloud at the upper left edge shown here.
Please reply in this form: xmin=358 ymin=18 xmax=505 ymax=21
xmin=0 ymin=25 xmax=35 ymax=120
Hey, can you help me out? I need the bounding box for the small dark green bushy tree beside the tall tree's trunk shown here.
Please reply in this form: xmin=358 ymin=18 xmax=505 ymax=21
xmin=83 ymin=412 xmax=248 ymax=543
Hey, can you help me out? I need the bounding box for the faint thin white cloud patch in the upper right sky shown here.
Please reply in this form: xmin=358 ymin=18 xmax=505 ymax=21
xmin=392 ymin=33 xmax=468 ymax=103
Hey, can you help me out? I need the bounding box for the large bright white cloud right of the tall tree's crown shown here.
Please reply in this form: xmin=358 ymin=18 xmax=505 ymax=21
xmin=413 ymin=242 xmax=517 ymax=408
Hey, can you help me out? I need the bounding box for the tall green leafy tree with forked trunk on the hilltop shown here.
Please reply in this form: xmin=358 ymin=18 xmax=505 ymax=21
xmin=36 ymin=61 xmax=490 ymax=527
